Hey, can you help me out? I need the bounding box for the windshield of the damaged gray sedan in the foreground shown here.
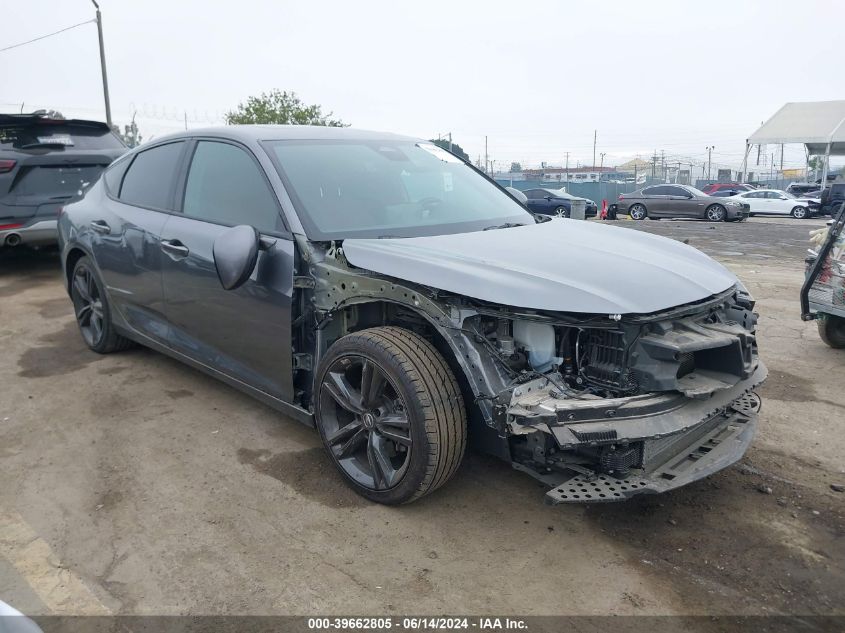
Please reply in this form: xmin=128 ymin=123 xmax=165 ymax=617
xmin=266 ymin=140 xmax=534 ymax=240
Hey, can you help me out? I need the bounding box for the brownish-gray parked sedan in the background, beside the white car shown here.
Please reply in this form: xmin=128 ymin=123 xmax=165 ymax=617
xmin=617 ymin=185 xmax=748 ymax=222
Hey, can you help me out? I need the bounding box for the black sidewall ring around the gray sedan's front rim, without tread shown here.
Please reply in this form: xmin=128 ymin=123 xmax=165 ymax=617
xmin=314 ymin=334 xmax=432 ymax=505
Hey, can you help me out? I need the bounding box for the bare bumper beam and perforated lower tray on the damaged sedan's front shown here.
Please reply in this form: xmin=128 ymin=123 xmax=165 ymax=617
xmin=508 ymin=362 xmax=768 ymax=504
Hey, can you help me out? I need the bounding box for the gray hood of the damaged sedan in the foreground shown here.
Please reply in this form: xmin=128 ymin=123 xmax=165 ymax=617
xmin=343 ymin=219 xmax=737 ymax=314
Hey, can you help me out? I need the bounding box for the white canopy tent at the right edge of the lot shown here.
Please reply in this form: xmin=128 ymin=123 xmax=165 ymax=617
xmin=742 ymin=100 xmax=845 ymax=183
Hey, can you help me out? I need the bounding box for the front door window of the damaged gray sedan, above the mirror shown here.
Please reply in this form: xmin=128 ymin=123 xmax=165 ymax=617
xmin=182 ymin=141 xmax=282 ymax=233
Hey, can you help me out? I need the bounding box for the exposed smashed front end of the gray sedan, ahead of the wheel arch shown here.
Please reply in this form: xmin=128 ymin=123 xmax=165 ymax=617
xmin=458 ymin=289 xmax=766 ymax=503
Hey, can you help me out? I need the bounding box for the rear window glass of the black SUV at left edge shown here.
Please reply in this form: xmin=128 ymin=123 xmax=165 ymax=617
xmin=0 ymin=123 xmax=126 ymax=150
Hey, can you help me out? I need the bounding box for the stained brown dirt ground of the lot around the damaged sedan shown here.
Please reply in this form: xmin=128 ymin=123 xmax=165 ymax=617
xmin=0 ymin=218 xmax=845 ymax=615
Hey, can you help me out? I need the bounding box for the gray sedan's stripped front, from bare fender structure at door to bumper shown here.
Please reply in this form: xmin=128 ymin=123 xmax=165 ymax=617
xmin=303 ymin=237 xmax=767 ymax=504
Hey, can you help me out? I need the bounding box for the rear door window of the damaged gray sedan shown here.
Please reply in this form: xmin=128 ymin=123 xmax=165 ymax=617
xmin=118 ymin=141 xmax=185 ymax=210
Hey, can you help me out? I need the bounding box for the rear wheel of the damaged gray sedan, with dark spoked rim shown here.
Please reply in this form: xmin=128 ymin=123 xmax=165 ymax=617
xmin=70 ymin=257 xmax=134 ymax=354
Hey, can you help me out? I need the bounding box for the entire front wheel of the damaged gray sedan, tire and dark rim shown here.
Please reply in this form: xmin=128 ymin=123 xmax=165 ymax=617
xmin=314 ymin=327 xmax=467 ymax=505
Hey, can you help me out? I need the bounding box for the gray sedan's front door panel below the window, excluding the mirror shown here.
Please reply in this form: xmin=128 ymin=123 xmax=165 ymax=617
xmin=162 ymin=215 xmax=294 ymax=401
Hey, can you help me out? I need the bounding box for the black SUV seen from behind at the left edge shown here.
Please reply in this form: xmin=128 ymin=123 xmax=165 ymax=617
xmin=0 ymin=112 xmax=127 ymax=248
